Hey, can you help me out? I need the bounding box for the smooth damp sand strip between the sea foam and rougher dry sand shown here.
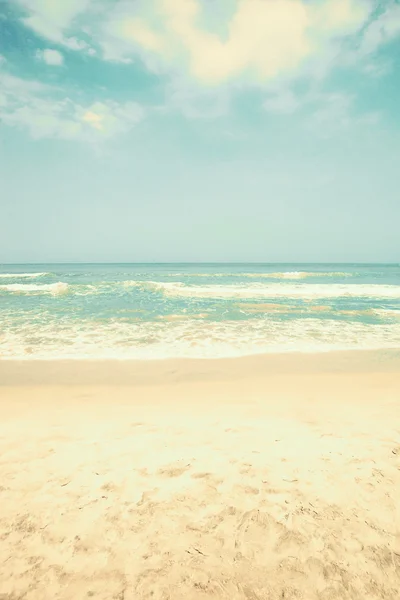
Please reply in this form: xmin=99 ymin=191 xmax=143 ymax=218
xmin=0 ymin=349 xmax=400 ymax=390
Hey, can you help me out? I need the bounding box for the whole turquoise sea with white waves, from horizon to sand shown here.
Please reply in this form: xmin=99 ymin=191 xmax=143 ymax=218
xmin=0 ymin=264 xmax=400 ymax=359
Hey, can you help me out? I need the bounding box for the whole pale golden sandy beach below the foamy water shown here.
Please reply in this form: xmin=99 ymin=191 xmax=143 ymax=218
xmin=0 ymin=353 xmax=400 ymax=600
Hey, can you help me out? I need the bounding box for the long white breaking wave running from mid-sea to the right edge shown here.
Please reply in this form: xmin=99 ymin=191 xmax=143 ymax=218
xmin=129 ymin=281 xmax=400 ymax=300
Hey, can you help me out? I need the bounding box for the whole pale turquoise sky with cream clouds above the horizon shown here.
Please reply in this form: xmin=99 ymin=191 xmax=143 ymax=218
xmin=0 ymin=0 xmax=400 ymax=263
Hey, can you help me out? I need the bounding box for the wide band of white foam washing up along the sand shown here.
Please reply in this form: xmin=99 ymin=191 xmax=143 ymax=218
xmin=0 ymin=318 xmax=400 ymax=360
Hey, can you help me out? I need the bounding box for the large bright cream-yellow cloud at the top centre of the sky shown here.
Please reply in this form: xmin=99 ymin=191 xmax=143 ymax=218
xmin=103 ymin=0 xmax=369 ymax=86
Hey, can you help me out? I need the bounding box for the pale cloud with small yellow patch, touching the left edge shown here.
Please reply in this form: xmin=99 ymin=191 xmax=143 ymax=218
xmin=0 ymin=73 xmax=144 ymax=143
